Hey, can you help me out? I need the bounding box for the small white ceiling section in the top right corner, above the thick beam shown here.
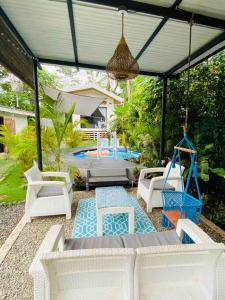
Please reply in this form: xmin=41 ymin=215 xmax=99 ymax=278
xmin=179 ymin=0 xmax=225 ymax=20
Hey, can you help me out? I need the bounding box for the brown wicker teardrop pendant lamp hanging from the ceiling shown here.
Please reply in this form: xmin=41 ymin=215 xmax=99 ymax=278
xmin=106 ymin=10 xmax=139 ymax=80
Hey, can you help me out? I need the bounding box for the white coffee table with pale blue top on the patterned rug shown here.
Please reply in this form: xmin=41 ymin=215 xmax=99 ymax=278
xmin=95 ymin=186 xmax=134 ymax=236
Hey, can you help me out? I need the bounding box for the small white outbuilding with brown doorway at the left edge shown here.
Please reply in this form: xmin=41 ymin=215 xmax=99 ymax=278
xmin=0 ymin=105 xmax=34 ymax=152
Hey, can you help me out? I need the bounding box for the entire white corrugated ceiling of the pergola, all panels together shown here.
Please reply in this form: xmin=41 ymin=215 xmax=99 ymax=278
xmin=0 ymin=0 xmax=225 ymax=74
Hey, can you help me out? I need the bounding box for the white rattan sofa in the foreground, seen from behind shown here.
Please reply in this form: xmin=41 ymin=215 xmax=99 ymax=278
xmin=29 ymin=219 xmax=225 ymax=300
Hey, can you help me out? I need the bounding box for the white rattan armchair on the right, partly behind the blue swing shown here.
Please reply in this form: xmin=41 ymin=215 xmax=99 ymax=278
xmin=137 ymin=162 xmax=184 ymax=212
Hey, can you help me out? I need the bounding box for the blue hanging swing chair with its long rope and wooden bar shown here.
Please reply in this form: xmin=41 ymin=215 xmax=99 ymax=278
xmin=162 ymin=14 xmax=202 ymax=227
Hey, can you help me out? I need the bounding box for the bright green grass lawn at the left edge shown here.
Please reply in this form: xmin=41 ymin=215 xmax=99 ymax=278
xmin=0 ymin=160 xmax=26 ymax=203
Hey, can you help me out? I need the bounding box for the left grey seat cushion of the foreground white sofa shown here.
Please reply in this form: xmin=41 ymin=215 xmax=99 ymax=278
xmin=64 ymin=235 xmax=124 ymax=250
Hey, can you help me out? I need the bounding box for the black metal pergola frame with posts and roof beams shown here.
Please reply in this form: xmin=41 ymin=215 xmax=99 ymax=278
xmin=0 ymin=0 xmax=225 ymax=169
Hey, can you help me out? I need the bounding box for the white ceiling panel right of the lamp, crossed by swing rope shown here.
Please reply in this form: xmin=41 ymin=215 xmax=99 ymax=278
xmin=139 ymin=21 xmax=222 ymax=72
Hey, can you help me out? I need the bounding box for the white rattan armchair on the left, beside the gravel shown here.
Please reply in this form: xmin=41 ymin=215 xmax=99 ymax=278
xmin=24 ymin=164 xmax=73 ymax=222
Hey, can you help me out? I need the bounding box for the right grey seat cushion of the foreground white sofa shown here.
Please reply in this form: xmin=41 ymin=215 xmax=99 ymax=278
xmin=122 ymin=230 xmax=181 ymax=248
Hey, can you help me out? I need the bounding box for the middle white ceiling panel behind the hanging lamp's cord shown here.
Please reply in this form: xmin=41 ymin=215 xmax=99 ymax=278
xmin=73 ymin=5 xmax=162 ymax=65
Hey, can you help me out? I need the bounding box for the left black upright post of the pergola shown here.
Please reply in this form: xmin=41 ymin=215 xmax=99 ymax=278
xmin=33 ymin=58 xmax=42 ymax=170
